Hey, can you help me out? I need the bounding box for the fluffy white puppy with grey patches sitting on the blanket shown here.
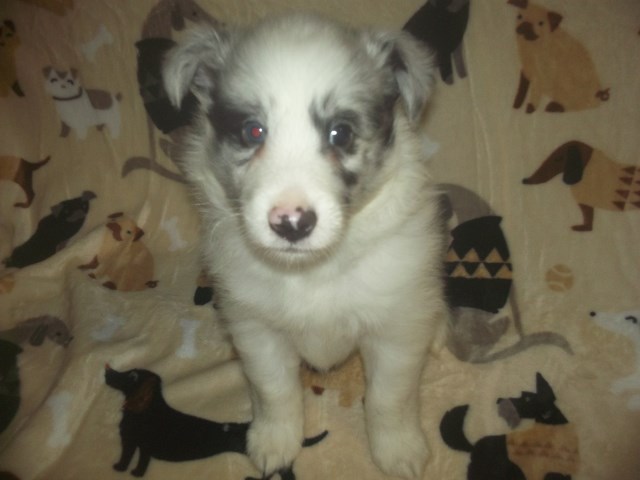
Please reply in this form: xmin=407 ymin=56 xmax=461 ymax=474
xmin=163 ymin=15 xmax=446 ymax=477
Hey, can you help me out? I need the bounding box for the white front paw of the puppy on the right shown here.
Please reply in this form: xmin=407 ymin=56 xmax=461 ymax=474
xmin=369 ymin=426 xmax=429 ymax=479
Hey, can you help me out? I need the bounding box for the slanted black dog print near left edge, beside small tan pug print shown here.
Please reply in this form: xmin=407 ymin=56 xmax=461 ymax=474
xmin=4 ymin=191 xmax=96 ymax=268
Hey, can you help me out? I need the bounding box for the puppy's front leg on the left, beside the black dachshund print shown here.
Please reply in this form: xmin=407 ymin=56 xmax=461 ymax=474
xmin=231 ymin=321 xmax=304 ymax=474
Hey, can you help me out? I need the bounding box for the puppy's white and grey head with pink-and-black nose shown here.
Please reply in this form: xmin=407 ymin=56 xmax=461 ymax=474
xmin=163 ymin=15 xmax=432 ymax=261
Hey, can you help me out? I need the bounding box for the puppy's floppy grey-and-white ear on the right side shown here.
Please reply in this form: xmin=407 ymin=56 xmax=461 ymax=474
xmin=364 ymin=31 xmax=435 ymax=123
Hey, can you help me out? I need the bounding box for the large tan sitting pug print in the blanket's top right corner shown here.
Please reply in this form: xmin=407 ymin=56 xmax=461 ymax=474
xmin=508 ymin=0 xmax=609 ymax=113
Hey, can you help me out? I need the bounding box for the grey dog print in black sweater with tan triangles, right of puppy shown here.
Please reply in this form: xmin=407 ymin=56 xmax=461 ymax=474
xmin=438 ymin=183 xmax=572 ymax=363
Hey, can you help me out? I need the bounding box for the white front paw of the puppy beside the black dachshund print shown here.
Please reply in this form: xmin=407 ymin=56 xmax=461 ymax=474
xmin=247 ymin=419 xmax=303 ymax=475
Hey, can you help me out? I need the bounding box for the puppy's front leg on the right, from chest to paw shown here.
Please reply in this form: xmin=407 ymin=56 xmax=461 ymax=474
xmin=361 ymin=338 xmax=428 ymax=478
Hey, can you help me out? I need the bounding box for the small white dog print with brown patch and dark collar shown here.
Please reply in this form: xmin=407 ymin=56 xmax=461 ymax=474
xmin=42 ymin=67 xmax=122 ymax=140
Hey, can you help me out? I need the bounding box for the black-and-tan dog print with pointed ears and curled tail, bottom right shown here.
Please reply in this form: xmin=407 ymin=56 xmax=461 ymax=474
xmin=440 ymin=373 xmax=579 ymax=480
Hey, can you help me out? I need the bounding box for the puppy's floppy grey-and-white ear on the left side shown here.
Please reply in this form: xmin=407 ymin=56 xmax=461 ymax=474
xmin=162 ymin=26 xmax=231 ymax=110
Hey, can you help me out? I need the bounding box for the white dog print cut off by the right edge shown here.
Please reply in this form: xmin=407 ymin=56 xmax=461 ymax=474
xmin=591 ymin=309 xmax=640 ymax=410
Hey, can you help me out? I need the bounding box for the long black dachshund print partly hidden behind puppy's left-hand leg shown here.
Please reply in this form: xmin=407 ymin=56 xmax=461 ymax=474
xmin=105 ymin=365 xmax=328 ymax=480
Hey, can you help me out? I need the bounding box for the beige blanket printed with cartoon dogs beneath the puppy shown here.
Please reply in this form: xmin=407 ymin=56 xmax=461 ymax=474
xmin=0 ymin=0 xmax=640 ymax=480
